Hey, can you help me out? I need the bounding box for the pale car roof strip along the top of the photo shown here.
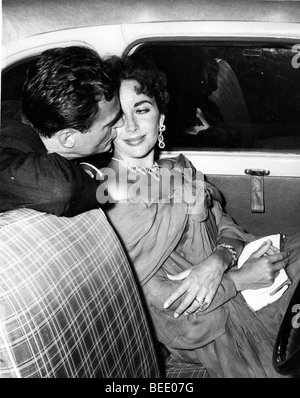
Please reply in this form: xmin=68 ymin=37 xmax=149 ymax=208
xmin=2 ymin=0 xmax=300 ymax=44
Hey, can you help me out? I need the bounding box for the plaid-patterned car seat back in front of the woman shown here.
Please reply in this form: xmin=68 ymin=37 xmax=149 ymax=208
xmin=0 ymin=209 xmax=159 ymax=378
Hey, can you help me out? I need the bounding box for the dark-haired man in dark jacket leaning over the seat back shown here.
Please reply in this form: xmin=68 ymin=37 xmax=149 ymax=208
xmin=0 ymin=46 xmax=122 ymax=216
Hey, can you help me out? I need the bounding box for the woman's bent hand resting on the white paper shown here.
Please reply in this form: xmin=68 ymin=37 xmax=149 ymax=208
xmin=228 ymin=240 xmax=289 ymax=291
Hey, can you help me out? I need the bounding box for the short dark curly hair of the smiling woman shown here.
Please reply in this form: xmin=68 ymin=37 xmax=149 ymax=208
xmin=105 ymin=54 xmax=169 ymax=113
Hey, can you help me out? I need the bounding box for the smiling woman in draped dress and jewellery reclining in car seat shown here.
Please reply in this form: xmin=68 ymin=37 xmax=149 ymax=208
xmin=100 ymin=56 xmax=300 ymax=377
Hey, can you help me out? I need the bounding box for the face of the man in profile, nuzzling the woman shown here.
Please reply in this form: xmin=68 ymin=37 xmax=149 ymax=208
xmin=74 ymin=96 xmax=123 ymax=157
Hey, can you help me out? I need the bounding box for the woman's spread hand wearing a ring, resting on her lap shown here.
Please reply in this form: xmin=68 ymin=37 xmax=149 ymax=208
xmin=164 ymin=252 xmax=227 ymax=318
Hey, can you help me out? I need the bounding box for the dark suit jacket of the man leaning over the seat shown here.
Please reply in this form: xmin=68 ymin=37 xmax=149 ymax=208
xmin=0 ymin=103 xmax=99 ymax=217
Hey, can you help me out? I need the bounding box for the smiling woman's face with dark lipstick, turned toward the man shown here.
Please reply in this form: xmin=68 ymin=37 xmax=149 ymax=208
xmin=114 ymin=80 xmax=164 ymax=162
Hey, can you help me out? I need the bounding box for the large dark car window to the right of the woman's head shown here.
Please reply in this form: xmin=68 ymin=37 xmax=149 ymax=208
xmin=138 ymin=42 xmax=300 ymax=152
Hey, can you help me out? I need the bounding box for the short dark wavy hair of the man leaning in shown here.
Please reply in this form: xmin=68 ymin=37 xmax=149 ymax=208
xmin=22 ymin=46 xmax=117 ymax=138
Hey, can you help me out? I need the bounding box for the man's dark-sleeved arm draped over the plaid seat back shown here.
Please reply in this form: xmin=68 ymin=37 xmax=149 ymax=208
xmin=0 ymin=148 xmax=99 ymax=217
